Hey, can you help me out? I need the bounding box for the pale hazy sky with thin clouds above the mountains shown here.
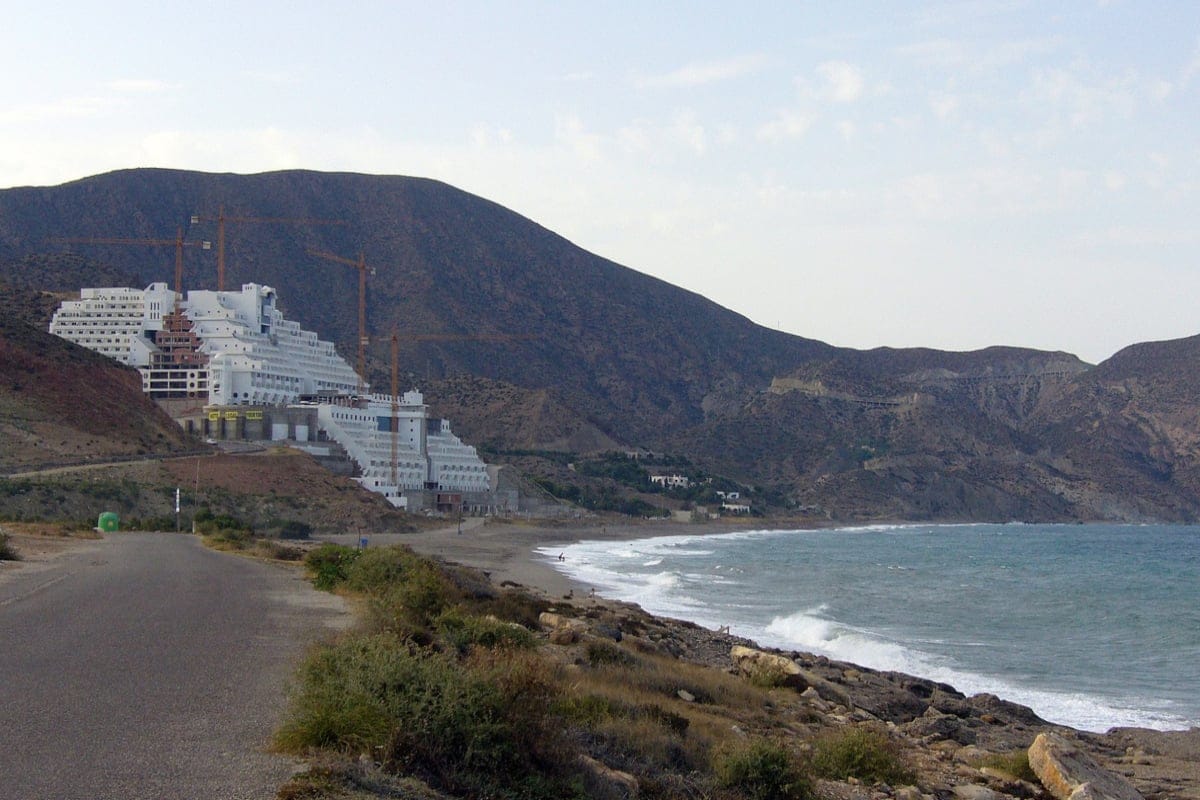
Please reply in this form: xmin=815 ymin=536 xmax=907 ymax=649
xmin=0 ymin=0 xmax=1200 ymax=361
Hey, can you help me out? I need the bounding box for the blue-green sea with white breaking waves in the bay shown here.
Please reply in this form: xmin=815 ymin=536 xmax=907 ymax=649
xmin=541 ymin=524 xmax=1200 ymax=732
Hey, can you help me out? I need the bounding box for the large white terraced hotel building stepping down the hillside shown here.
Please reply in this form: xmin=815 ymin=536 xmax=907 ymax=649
xmin=50 ymin=283 xmax=491 ymax=505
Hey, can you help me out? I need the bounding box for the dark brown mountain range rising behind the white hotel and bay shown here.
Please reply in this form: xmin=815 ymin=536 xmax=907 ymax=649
xmin=0 ymin=170 xmax=1200 ymax=519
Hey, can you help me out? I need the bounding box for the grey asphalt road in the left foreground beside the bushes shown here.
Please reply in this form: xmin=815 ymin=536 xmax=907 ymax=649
xmin=0 ymin=534 xmax=348 ymax=800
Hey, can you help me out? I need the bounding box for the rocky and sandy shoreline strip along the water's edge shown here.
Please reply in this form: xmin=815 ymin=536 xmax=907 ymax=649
xmin=397 ymin=523 xmax=1200 ymax=800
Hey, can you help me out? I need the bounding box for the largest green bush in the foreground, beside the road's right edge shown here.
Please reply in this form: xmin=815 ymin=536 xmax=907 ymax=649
xmin=276 ymin=633 xmax=575 ymax=799
